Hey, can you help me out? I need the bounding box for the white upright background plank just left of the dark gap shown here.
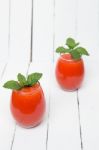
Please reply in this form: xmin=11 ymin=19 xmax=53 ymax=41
xmin=9 ymin=0 xmax=31 ymax=61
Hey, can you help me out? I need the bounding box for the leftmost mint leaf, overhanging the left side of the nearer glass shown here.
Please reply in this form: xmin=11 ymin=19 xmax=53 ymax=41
xmin=3 ymin=80 xmax=21 ymax=90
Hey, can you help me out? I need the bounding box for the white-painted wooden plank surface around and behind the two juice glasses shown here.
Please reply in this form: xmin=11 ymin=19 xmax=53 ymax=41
xmin=0 ymin=0 xmax=99 ymax=150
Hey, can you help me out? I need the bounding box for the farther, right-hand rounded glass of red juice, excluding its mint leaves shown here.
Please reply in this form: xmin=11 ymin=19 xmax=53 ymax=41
xmin=55 ymin=53 xmax=84 ymax=91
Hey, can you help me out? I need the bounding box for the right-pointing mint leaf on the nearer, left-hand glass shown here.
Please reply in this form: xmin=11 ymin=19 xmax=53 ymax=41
xmin=27 ymin=73 xmax=42 ymax=86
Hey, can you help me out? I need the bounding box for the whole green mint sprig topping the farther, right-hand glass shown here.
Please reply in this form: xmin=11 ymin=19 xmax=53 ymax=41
xmin=56 ymin=38 xmax=89 ymax=59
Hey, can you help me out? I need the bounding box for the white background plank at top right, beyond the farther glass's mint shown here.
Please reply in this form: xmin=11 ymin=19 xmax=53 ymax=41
xmin=77 ymin=0 xmax=99 ymax=58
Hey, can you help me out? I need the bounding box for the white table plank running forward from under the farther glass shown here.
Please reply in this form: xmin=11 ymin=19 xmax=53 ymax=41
xmin=48 ymin=62 xmax=81 ymax=150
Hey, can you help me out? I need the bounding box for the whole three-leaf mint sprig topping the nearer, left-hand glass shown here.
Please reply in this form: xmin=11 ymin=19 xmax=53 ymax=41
xmin=3 ymin=72 xmax=42 ymax=90
